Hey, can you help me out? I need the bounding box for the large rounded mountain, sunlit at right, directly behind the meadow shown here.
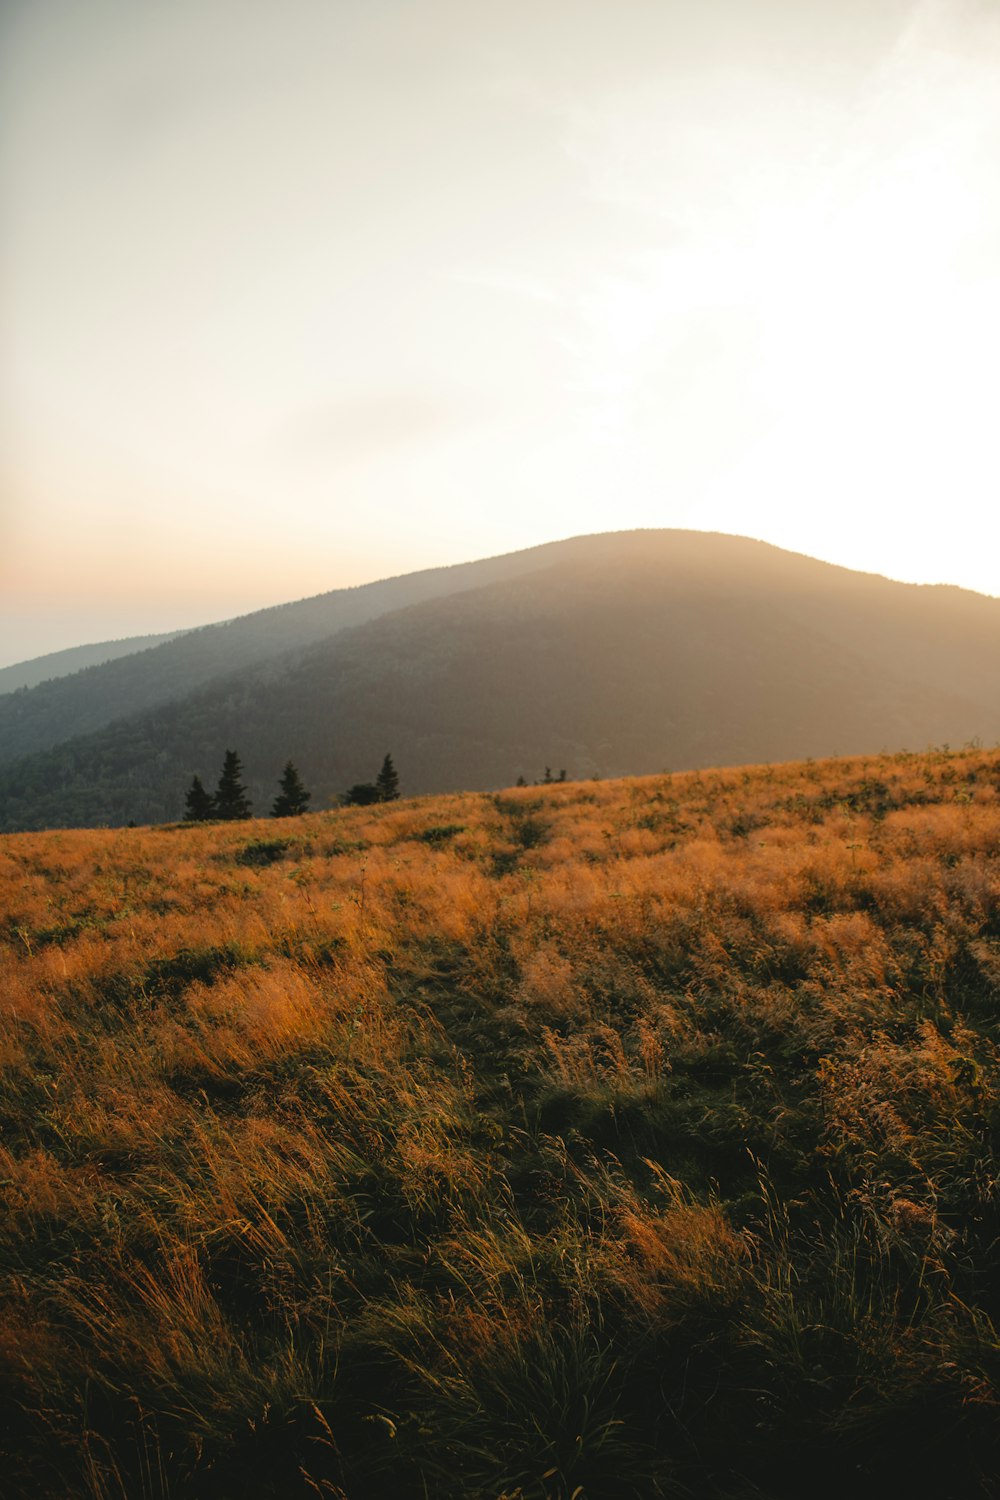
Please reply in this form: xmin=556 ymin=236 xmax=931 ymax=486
xmin=0 ymin=533 xmax=1000 ymax=828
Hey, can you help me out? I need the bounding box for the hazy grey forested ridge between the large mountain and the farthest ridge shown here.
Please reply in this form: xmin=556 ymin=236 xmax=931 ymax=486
xmin=0 ymin=543 xmax=565 ymax=764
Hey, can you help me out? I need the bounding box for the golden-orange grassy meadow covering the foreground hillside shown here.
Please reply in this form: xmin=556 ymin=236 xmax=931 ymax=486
xmin=0 ymin=749 xmax=1000 ymax=1500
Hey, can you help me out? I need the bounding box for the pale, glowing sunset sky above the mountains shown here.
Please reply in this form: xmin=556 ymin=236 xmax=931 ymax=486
xmin=0 ymin=0 xmax=1000 ymax=665
